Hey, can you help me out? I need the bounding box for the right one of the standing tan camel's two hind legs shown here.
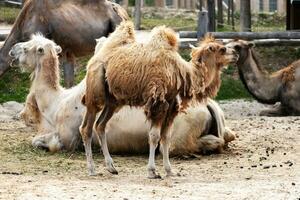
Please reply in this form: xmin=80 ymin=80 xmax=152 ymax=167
xmin=95 ymin=106 xmax=118 ymax=174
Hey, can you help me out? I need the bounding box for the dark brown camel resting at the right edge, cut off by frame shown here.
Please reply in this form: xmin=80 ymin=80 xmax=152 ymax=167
xmin=227 ymin=40 xmax=300 ymax=116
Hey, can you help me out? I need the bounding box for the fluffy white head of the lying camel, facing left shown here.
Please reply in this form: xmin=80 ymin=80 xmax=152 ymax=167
xmin=9 ymin=33 xmax=62 ymax=72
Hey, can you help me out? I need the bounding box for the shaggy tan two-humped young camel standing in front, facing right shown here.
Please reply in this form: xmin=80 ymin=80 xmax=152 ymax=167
xmin=80 ymin=22 xmax=237 ymax=178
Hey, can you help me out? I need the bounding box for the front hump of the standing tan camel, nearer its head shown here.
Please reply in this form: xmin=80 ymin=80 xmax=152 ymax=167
xmin=151 ymin=26 xmax=178 ymax=51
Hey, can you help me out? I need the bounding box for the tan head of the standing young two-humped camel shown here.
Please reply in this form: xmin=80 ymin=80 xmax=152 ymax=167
xmin=191 ymin=35 xmax=238 ymax=86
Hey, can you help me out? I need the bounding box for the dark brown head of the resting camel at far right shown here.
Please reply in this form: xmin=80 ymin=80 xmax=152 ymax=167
xmin=226 ymin=40 xmax=255 ymax=64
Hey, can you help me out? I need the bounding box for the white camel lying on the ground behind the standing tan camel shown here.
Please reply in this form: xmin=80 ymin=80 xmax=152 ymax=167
xmin=10 ymin=34 xmax=235 ymax=155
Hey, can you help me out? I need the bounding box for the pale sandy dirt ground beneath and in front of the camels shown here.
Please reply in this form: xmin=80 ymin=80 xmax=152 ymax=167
xmin=0 ymin=100 xmax=300 ymax=200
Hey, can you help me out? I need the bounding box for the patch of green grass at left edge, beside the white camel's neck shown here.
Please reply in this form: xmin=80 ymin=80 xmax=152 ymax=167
xmin=0 ymin=68 xmax=30 ymax=103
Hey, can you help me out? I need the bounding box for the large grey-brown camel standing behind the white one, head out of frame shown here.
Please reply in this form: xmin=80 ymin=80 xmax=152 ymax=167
xmin=0 ymin=0 xmax=128 ymax=87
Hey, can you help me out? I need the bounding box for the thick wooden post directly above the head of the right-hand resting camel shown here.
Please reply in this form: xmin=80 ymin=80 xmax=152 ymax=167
xmin=240 ymin=0 xmax=251 ymax=32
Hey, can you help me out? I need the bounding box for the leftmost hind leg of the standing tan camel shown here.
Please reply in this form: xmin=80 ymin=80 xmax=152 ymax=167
xmin=80 ymin=109 xmax=96 ymax=176
